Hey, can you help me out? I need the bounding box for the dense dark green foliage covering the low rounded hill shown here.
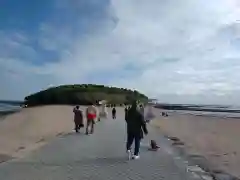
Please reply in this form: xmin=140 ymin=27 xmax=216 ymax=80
xmin=25 ymin=84 xmax=148 ymax=106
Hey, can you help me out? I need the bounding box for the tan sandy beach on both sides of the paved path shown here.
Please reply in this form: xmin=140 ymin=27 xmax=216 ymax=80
xmin=0 ymin=106 xmax=240 ymax=177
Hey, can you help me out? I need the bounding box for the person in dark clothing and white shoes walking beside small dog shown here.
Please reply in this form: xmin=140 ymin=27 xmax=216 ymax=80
xmin=126 ymin=102 xmax=148 ymax=159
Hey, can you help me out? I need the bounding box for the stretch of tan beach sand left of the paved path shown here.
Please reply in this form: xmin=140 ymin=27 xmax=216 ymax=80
xmin=0 ymin=106 xmax=80 ymax=162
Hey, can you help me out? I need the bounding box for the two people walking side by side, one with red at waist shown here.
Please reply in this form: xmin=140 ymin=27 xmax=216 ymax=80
xmin=73 ymin=104 xmax=100 ymax=134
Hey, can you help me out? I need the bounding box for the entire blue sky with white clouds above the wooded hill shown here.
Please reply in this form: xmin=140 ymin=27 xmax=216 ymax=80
xmin=0 ymin=0 xmax=240 ymax=105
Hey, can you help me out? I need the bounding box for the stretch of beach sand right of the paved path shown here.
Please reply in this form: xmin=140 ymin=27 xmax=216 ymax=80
xmin=151 ymin=110 xmax=240 ymax=177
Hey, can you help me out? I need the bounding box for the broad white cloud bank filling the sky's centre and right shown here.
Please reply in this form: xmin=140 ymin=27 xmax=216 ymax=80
xmin=1 ymin=0 xmax=240 ymax=103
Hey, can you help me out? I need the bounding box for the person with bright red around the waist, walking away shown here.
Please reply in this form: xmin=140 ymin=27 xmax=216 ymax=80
xmin=86 ymin=104 xmax=97 ymax=134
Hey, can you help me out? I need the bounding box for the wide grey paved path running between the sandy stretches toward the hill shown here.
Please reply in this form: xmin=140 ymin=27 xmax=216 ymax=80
xmin=0 ymin=109 xmax=199 ymax=180
